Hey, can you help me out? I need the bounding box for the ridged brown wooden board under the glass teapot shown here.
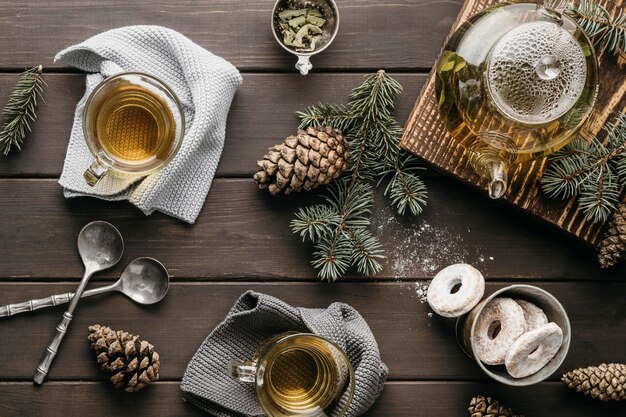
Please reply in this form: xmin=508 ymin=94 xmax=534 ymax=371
xmin=401 ymin=0 xmax=626 ymax=245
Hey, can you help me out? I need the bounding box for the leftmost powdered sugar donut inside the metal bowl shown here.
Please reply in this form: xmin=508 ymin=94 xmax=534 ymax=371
xmin=472 ymin=298 xmax=526 ymax=365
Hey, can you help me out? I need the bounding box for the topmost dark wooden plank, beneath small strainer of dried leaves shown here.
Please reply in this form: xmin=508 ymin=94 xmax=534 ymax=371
xmin=0 ymin=0 xmax=461 ymax=71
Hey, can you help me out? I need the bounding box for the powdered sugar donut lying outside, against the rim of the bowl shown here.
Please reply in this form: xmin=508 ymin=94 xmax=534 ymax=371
xmin=426 ymin=264 xmax=485 ymax=317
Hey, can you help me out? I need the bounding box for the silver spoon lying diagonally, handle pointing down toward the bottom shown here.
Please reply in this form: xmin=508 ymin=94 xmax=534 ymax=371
xmin=33 ymin=221 xmax=124 ymax=384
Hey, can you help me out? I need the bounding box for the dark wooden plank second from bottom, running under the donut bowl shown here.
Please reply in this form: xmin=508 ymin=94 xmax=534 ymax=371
xmin=0 ymin=282 xmax=626 ymax=382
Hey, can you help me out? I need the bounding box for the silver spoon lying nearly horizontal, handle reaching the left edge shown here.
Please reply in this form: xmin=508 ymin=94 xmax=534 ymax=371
xmin=0 ymin=258 xmax=170 ymax=317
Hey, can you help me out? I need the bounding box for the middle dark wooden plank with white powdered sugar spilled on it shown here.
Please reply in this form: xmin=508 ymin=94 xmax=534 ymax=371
xmin=0 ymin=178 xmax=626 ymax=281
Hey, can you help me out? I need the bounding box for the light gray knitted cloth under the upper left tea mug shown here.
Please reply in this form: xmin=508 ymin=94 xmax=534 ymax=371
xmin=55 ymin=26 xmax=241 ymax=223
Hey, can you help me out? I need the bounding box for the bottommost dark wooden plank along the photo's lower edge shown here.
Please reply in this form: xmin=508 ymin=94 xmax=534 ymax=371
xmin=0 ymin=382 xmax=624 ymax=417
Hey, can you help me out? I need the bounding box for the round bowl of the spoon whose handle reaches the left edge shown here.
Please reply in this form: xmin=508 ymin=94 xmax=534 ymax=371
xmin=115 ymin=258 xmax=170 ymax=304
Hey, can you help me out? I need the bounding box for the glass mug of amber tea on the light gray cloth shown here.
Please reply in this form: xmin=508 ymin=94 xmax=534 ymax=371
xmin=83 ymin=72 xmax=185 ymax=186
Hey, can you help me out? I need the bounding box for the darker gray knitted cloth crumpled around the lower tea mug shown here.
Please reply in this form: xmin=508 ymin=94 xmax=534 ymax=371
xmin=181 ymin=291 xmax=388 ymax=417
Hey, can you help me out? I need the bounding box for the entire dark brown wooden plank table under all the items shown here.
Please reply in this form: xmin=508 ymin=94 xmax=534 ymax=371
xmin=0 ymin=0 xmax=626 ymax=417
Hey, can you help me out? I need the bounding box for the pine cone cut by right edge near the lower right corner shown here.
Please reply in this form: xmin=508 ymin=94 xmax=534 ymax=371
xmin=561 ymin=363 xmax=626 ymax=401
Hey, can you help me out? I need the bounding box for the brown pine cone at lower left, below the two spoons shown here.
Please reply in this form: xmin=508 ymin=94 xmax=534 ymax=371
xmin=87 ymin=324 xmax=161 ymax=392
